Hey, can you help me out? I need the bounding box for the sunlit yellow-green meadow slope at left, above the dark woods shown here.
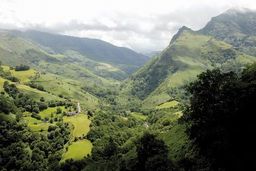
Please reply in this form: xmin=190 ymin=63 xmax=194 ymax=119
xmin=0 ymin=65 xmax=100 ymax=110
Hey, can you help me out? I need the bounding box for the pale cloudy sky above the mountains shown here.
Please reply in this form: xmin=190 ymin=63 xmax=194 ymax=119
xmin=0 ymin=0 xmax=256 ymax=52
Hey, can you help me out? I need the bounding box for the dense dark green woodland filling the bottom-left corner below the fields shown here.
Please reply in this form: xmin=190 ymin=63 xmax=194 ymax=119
xmin=0 ymin=121 xmax=69 ymax=171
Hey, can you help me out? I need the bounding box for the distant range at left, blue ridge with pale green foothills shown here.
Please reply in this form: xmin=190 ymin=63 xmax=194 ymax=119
xmin=0 ymin=30 xmax=149 ymax=80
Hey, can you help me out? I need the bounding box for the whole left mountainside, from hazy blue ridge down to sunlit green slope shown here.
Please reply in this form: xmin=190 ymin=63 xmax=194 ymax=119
xmin=0 ymin=30 xmax=148 ymax=109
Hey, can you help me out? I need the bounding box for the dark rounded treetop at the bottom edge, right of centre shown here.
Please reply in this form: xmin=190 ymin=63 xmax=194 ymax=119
xmin=136 ymin=133 xmax=171 ymax=171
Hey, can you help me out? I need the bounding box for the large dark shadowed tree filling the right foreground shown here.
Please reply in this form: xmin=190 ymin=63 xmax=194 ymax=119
xmin=183 ymin=65 xmax=256 ymax=170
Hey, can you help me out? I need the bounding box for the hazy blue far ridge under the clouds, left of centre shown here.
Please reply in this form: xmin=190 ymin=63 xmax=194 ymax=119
xmin=13 ymin=31 xmax=148 ymax=73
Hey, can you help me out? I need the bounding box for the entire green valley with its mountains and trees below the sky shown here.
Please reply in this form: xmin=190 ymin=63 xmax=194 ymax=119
xmin=0 ymin=7 xmax=256 ymax=171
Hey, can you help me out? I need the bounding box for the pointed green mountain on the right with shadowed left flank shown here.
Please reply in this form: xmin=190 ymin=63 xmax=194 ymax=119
xmin=121 ymin=9 xmax=256 ymax=108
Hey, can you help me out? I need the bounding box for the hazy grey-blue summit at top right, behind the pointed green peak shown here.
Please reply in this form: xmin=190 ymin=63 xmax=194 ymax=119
xmin=200 ymin=9 xmax=256 ymax=56
